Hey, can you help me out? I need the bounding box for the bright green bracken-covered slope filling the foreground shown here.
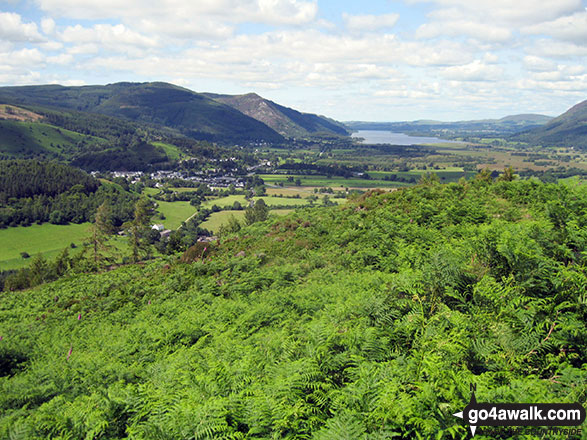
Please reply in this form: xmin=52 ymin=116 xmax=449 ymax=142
xmin=0 ymin=174 xmax=587 ymax=440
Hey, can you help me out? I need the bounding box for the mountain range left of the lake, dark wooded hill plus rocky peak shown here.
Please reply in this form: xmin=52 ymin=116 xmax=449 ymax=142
xmin=0 ymin=82 xmax=348 ymax=143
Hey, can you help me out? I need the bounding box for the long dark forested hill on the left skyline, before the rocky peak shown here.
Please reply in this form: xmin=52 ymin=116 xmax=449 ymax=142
xmin=0 ymin=83 xmax=282 ymax=141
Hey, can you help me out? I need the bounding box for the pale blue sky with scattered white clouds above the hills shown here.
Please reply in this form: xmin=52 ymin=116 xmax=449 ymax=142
xmin=0 ymin=0 xmax=587 ymax=121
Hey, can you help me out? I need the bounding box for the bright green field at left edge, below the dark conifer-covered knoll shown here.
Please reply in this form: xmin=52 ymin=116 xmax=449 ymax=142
xmin=0 ymin=223 xmax=90 ymax=270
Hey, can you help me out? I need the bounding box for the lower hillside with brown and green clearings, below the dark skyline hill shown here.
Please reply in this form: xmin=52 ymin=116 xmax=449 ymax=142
xmin=0 ymin=105 xmax=227 ymax=171
